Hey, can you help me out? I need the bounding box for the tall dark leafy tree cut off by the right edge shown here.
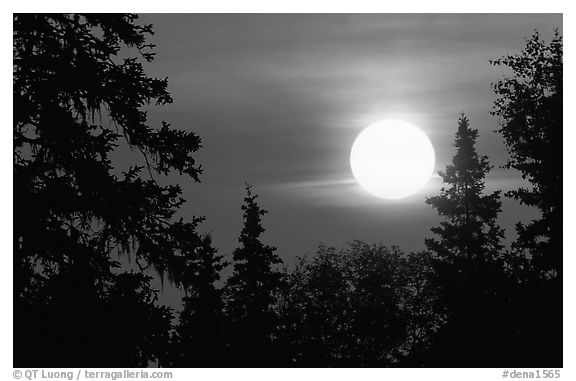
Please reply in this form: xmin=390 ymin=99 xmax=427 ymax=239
xmin=492 ymin=31 xmax=563 ymax=279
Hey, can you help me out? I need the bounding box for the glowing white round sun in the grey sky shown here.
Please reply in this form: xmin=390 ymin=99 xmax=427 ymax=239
xmin=350 ymin=119 xmax=435 ymax=200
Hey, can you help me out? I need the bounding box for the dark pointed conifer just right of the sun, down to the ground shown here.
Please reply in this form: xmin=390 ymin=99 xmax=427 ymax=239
xmin=426 ymin=115 xmax=505 ymax=366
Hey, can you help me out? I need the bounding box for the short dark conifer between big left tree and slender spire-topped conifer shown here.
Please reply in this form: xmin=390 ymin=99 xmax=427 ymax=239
xmin=172 ymin=232 xmax=226 ymax=367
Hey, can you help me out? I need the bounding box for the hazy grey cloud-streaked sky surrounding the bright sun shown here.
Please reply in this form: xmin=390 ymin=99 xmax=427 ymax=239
xmin=134 ymin=14 xmax=562 ymax=270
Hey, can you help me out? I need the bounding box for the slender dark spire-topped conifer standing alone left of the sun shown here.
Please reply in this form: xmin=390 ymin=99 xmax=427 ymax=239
xmin=226 ymin=185 xmax=282 ymax=367
